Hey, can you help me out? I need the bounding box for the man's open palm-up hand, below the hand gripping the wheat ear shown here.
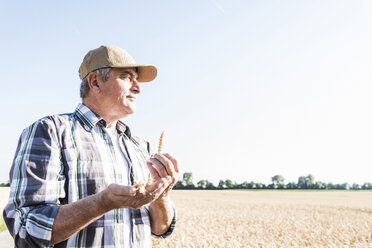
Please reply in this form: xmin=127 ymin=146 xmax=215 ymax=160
xmin=99 ymin=176 xmax=172 ymax=211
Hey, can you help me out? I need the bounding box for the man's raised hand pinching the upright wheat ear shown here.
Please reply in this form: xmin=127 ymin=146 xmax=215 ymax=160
xmin=147 ymin=153 xmax=179 ymax=198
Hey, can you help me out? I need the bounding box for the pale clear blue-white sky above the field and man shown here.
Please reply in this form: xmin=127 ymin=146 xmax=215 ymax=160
xmin=0 ymin=0 xmax=372 ymax=184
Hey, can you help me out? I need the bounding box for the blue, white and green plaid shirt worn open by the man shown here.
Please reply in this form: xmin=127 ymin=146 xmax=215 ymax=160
xmin=3 ymin=104 xmax=176 ymax=247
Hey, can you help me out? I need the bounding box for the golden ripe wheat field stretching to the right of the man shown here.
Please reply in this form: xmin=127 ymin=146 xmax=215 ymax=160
xmin=153 ymin=190 xmax=372 ymax=248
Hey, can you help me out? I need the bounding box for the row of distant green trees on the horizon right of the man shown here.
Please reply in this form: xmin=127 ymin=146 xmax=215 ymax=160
xmin=174 ymin=172 xmax=372 ymax=190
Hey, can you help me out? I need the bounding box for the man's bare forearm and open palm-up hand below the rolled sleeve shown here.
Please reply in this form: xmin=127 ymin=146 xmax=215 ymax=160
xmin=51 ymin=177 xmax=172 ymax=244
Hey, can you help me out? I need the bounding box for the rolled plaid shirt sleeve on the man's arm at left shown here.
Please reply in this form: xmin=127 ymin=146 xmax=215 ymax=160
xmin=3 ymin=119 xmax=65 ymax=247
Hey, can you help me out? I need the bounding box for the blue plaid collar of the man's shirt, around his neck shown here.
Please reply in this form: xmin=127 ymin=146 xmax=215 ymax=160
xmin=75 ymin=103 xmax=131 ymax=138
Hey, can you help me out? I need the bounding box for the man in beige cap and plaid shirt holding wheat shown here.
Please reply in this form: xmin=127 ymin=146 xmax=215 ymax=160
xmin=3 ymin=46 xmax=178 ymax=247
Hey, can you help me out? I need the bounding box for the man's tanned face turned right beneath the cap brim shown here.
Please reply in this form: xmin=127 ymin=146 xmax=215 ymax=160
xmin=100 ymin=68 xmax=141 ymax=118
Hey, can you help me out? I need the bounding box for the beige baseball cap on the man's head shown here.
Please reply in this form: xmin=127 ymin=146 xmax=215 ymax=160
xmin=79 ymin=45 xmax=158 ymax=82
